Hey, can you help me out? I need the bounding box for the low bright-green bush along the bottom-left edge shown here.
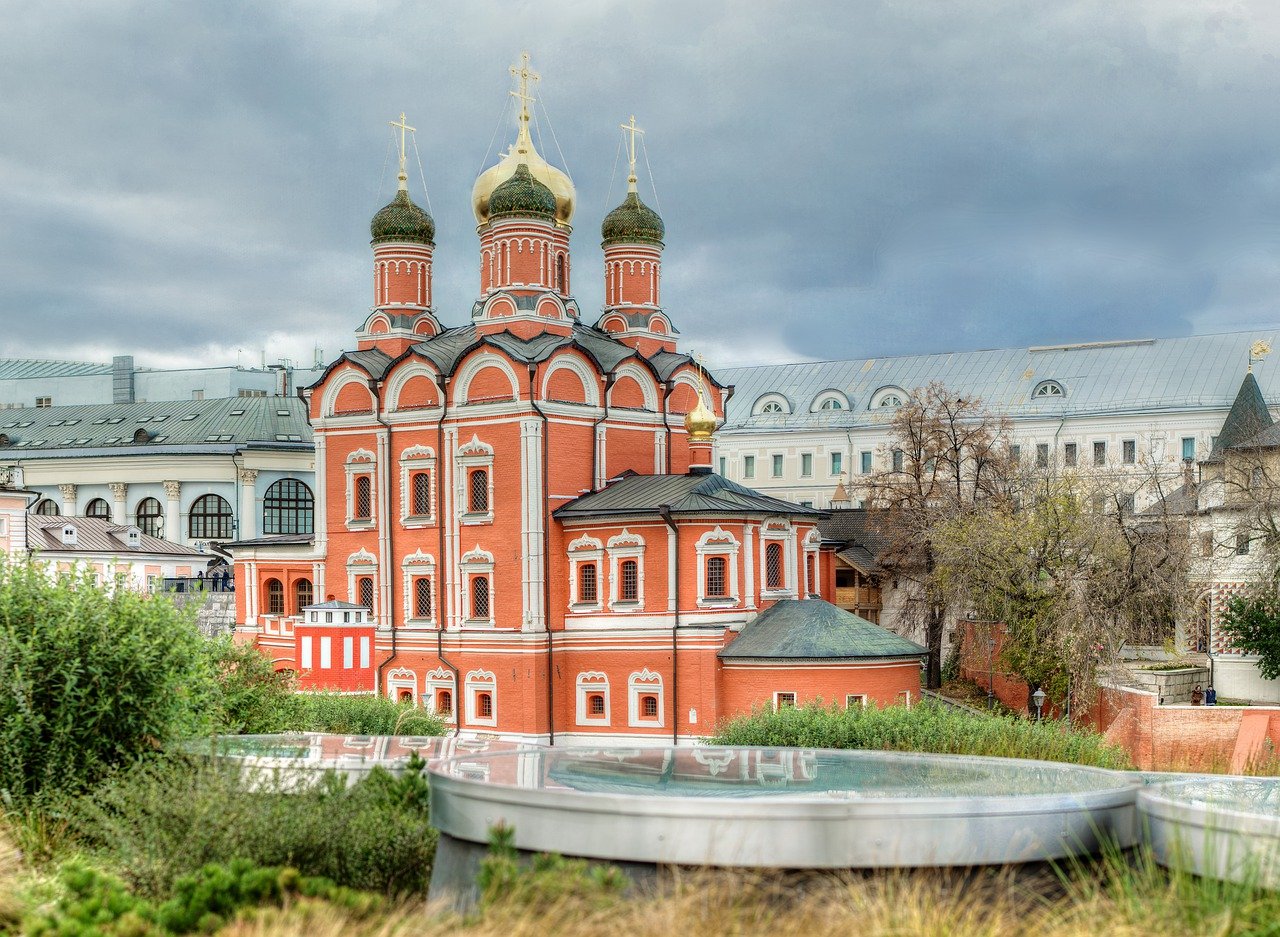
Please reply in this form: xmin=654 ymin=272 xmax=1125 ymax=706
xmin=23 ymin=859 xmax=381 ymax=937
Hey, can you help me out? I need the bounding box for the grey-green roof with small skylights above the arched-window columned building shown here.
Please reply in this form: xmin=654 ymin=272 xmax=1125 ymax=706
xmin=0 ymin=397 xmax=312 ymax=461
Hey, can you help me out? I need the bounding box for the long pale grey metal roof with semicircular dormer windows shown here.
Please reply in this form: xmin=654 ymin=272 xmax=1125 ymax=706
xmin=716 ymin=330 xmax=1280 ymax=431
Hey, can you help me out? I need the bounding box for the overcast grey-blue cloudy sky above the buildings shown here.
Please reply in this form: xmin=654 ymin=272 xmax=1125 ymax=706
xmin=0 ymin=0 xmax=1280 ymax=365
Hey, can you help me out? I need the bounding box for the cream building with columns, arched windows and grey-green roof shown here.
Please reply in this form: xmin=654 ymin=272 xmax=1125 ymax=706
xmin=0 ymin=397 xmax=315 ymax=548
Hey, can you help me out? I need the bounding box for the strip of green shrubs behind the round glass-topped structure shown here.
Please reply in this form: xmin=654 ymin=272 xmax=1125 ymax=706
xmin=709 ymin=703 xmax=1133 ymax=768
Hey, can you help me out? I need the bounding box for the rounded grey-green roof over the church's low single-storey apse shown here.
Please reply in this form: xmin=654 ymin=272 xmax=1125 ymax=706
xmin=719 ymin=599 xmax=927 ymax=661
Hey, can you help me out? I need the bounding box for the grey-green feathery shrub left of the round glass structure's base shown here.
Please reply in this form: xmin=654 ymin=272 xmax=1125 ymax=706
xmin=65 ymin=757 xmax=436 ymax=899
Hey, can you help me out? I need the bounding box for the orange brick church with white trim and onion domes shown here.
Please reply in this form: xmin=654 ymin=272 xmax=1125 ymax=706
xmin=232 ymin=61 xmax=924 ymax=744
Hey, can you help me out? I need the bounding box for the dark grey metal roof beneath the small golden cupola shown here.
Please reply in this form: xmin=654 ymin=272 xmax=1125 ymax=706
xmin=554 ymin=474 xmax=822 ymax=520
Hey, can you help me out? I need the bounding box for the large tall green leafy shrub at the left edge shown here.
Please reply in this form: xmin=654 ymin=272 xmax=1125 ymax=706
xmin=0 ymin=559 xmax=212 ymax=806
